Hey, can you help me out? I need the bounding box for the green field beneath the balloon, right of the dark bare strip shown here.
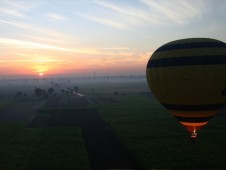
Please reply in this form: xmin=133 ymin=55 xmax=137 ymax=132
xmin=99 ymin=94 xmax=226 ymax=169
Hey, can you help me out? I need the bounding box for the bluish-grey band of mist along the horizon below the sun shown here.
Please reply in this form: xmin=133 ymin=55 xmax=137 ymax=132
xmin=0 ymin=75 xmax=149 ymax=100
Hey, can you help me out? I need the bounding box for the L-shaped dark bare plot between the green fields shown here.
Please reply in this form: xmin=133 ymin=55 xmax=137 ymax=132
xmin=31 ymin=109 xmax=138 ymax=170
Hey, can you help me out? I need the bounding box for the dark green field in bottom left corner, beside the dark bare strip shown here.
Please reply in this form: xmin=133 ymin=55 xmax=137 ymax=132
xmin=0 ymin=122 xmax=90 ymax=170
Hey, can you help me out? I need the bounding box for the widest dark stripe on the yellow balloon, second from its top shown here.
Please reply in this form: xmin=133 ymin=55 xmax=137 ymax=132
xmin=147 ymin=55 xmax=226 ymax=68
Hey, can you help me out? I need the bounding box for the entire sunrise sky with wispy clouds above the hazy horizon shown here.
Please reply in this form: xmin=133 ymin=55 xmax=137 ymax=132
xmin=0 ymin=0 xmax=226 ymax=76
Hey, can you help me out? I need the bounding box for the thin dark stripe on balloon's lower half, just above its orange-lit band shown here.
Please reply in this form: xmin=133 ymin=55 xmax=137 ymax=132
xmin=162 ymin=103 xmax=225 ymax=111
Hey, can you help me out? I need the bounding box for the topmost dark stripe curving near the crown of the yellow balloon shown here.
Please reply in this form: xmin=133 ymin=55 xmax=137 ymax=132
xmin=155 ymin=42 xmax=226 ymax=52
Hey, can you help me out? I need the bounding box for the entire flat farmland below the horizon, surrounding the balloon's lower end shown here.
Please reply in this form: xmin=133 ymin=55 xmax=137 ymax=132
xmin=0 ymin=76 xmax=226 ymax=169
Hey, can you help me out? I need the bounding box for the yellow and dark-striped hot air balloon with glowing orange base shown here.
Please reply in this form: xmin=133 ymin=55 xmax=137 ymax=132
xmin=146 ymin=38 xmax=226 ymax=139
